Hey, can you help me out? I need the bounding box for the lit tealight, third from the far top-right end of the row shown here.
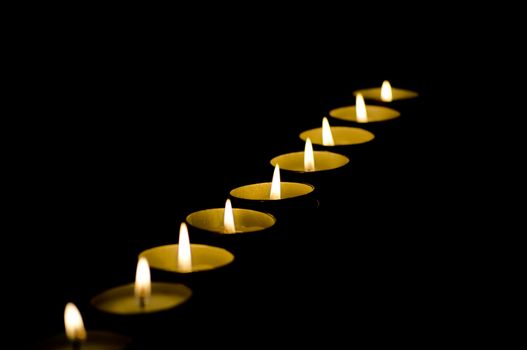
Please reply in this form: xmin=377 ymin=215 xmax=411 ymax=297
xmin=300 ymin=117 xmax=375 ymax=147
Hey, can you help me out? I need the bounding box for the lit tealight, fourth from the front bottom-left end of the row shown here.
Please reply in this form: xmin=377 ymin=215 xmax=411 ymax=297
xmin=186 ymin=199 xmax=276 ymax=235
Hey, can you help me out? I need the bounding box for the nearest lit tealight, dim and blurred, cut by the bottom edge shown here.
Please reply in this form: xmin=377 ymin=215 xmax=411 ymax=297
xmin=36 ymin=303 xmax=131 ymax=350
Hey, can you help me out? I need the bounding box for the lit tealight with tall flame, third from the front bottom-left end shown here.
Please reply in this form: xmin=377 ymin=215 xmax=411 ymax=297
xmin=139 ymin=222 xmax=234 ymax=273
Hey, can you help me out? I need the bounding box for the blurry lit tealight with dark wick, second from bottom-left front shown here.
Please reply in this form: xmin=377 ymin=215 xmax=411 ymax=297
xmin=91 ymin=257 xmax=192 ymax=315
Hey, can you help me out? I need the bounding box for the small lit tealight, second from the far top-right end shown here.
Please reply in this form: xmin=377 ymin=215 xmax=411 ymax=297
xmin=329 ymin=93 xmax=401 ymax=123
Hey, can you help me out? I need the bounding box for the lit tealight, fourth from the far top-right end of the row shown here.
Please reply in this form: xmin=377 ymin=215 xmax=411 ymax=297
xmin=271 ymin=137 xmax=349 ymax=173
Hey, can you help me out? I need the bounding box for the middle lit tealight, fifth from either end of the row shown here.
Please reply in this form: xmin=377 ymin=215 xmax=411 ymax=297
xmin=230 ymin=164 xmax=318 ymax=214
